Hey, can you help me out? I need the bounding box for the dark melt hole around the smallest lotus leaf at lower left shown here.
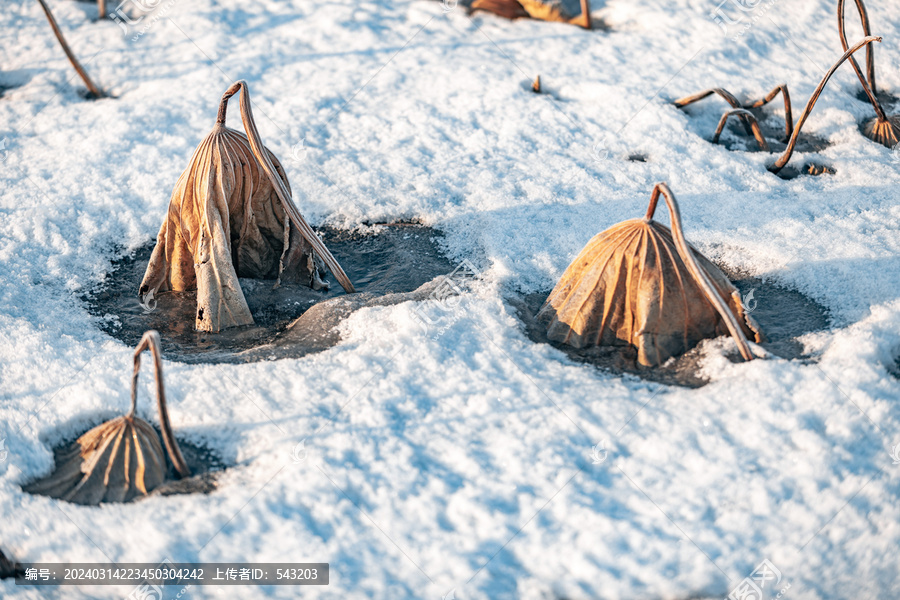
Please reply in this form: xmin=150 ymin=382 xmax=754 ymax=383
xmin=22 ymin=421 xmax=230 ymax=502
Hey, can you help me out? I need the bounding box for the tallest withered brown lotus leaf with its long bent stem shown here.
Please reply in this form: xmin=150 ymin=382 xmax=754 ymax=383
xmin=139 ymin=81 xmax=354 ymax=332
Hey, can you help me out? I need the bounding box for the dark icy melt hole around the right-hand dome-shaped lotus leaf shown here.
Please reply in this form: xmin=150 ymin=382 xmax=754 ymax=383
xmin=509 ymin=265 xmax=831 ymax=387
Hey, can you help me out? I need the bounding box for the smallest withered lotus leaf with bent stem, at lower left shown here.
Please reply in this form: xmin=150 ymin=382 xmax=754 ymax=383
xmin=25 ymin=331 xmax=191 ymax=505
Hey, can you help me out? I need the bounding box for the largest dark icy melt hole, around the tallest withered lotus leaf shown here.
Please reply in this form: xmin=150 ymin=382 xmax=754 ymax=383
xmin=84 ymin=223 xmax=454 ymax=363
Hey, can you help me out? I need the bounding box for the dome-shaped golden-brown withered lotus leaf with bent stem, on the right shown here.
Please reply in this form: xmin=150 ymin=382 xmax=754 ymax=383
xmin=538 ymin=183 xmax=763 ymax=367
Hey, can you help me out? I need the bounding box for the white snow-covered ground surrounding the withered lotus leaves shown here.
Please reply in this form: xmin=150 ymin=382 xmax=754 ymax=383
xmin=0 ymin=0 xmax=900 ymax=600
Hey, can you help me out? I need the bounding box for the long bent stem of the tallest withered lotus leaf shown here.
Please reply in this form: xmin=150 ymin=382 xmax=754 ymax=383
xmin=216 ymin=80 xmax=356 ymax=294
